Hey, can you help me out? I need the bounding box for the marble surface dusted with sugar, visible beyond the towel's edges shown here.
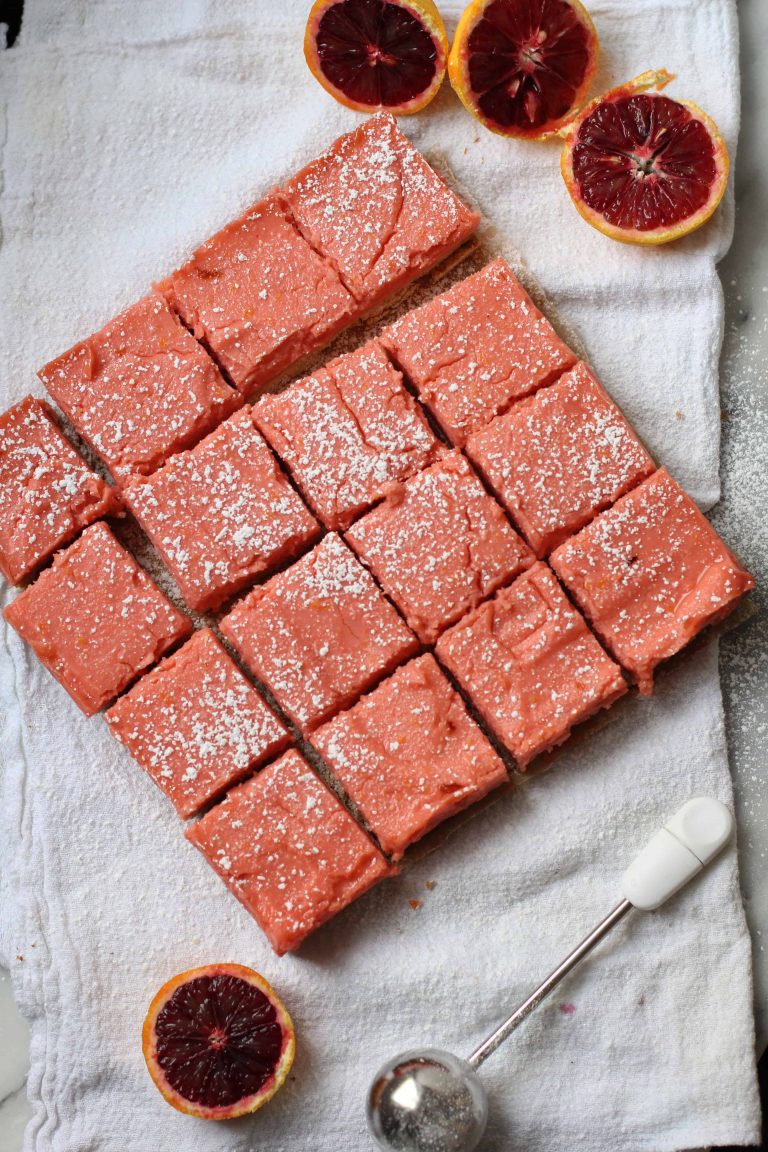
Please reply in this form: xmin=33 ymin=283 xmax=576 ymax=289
xmin=0 ymin=0 xmax=768 ymax=1152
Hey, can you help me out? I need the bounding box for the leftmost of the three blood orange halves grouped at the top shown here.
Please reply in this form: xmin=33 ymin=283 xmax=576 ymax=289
xmin=304 ymin=0 xmax=448 ymax=115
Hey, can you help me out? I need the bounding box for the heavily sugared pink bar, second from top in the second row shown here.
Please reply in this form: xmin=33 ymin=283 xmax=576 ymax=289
xmin=253 ymin=341 xmax=439 ymax=529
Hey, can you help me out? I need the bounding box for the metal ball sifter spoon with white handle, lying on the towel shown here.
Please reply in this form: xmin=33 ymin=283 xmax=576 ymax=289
xmin=367 ymin=796 xmax=733 ymax=1152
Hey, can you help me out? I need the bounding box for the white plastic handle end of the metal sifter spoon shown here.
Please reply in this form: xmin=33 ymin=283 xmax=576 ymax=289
xmin=623 ymin=796 xmax=733 ymax=912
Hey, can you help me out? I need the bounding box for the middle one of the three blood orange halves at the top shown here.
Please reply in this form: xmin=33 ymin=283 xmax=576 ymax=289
xmin=448 ymin=0 xmax=599 ymax=139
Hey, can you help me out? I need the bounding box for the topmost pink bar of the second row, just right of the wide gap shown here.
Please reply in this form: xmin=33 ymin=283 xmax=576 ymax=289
xmin=381 ymin=259 xmax=576 ymax=446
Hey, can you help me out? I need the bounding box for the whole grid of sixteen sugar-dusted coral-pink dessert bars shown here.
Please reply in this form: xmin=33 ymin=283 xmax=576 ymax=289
xmin=0 ymin=115 xmax=752 ymax=953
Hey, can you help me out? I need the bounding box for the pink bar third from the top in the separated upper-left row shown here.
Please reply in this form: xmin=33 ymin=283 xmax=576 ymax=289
xmin=38 ymin=294 xmax=241 ymax=480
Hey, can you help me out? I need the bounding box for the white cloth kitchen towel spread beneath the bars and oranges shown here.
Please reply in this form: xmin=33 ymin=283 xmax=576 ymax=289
xmin=0 ymin=0 xmax=759 ymax=1152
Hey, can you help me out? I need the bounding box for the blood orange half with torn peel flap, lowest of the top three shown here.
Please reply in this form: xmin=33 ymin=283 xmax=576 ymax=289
xmin=561 ymin=70 xmax=728 ymax=244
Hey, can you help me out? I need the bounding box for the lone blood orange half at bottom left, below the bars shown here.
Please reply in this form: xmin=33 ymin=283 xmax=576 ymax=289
xmin=142 ymin=964 xmax=295 ymax=1120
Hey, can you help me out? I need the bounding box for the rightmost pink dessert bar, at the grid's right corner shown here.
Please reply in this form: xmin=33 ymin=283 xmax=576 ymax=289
xmin=550 ymin=468 xmax=754 ymax=694
